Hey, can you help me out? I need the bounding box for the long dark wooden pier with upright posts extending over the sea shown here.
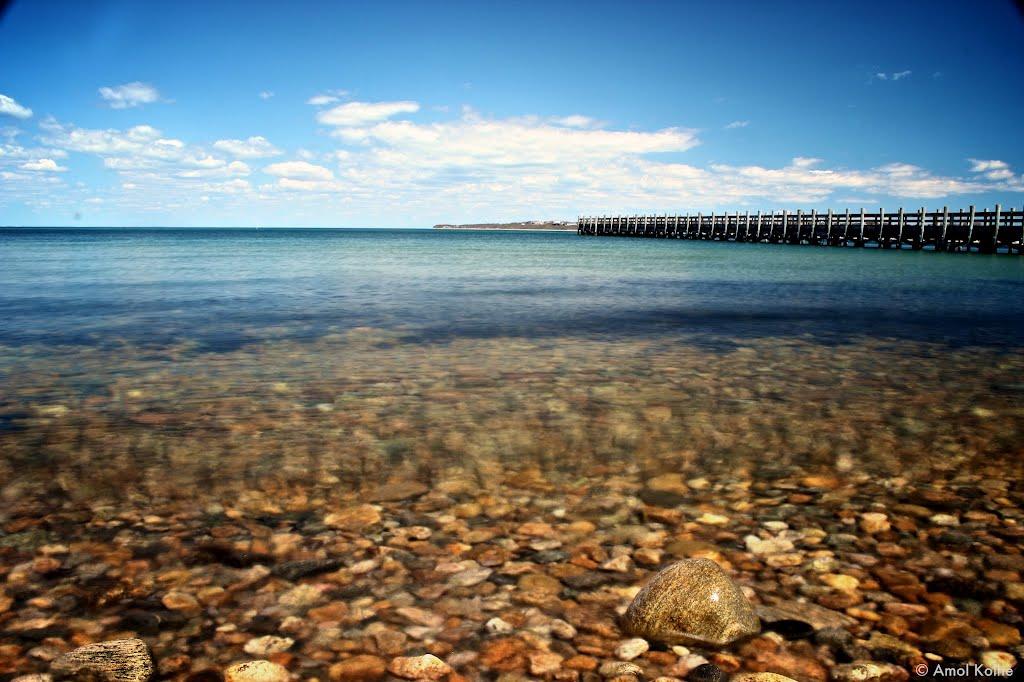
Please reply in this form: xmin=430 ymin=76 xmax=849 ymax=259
xmin=577 ymin=204 xmax=1024 ymax=255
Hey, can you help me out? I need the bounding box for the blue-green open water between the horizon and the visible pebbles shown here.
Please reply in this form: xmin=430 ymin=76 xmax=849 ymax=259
xmin=0 ymin=228 xmax=1024 ymax=350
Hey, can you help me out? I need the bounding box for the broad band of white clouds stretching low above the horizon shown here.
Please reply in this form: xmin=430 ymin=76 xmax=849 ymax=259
xmin=6 ymin=101 xmax=1024 ymax=221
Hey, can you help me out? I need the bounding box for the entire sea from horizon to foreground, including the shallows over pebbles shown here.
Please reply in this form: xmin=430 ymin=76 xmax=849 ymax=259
xmin=0 ymin=230 xmax=1024 ymax=680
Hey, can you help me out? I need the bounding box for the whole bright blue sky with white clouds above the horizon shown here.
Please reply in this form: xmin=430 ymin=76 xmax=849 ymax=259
xmin=0 ymin=0 xmax=1024 ymax=226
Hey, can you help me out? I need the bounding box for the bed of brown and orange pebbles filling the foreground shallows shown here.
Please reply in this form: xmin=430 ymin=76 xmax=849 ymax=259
xmin=0 ymin=328 xmax=1024 ymax=682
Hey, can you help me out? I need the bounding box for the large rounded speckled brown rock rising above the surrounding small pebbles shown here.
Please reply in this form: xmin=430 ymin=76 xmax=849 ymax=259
xmin=623 ymin=559 xmax=761 ymax=646
